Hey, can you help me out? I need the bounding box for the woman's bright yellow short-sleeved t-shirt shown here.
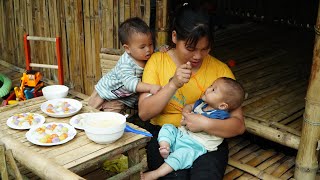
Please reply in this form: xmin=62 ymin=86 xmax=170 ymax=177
xmin=142 ymin=52 xmax=234 ymax=127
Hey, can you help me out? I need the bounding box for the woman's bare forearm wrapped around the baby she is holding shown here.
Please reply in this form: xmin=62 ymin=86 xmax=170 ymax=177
xmin=182 ymin=108 xmax=245 ymax=138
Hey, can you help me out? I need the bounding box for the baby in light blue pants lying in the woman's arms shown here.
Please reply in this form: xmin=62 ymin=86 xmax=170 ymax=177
xmin=141 ymin=77 xmax=244 ymax=180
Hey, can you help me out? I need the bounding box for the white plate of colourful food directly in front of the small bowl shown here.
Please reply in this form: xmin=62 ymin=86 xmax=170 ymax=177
xmin=41 ymin=98 xmax=82 ymax=117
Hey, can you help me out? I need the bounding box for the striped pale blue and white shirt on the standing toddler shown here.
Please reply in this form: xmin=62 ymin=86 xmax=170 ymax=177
xmin=95 ymin=52 xmax=144 ymax=107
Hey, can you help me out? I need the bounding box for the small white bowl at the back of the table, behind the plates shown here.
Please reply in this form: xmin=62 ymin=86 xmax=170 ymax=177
xmin=42 ymin=85 xmax=69 ymax=100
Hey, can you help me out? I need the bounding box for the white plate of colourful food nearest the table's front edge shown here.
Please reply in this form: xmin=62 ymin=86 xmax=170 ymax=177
xmin=26 ymin=122 xmax=77 ymax=146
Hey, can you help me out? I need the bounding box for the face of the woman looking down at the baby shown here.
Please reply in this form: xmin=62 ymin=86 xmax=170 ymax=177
xmin=174 ymin=32 xmax=210 ymax=69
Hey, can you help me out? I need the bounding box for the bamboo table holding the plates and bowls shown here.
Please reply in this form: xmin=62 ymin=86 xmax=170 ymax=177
xmin=0 ymin=93 xmax=150 ymax=177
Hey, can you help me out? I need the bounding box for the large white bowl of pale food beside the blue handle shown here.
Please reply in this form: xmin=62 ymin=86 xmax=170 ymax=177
xmin=83 ymin=112 xmax=126 ymax=144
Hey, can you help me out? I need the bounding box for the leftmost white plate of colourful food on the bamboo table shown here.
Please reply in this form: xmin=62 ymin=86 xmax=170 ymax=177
xmin=7 ymin=113 xmax=46 ymax=130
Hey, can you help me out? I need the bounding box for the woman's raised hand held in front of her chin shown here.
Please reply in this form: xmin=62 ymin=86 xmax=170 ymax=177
xmin=171 ymin=61 xmax=192 ymax=89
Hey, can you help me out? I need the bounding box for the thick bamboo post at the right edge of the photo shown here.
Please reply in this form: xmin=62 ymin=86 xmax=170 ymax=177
xmin=294 ymin=1 xmax=320 ymax=179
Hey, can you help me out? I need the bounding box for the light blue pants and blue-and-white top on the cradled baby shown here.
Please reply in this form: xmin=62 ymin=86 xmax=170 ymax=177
xmin=158 ymin=99 xmax=230 ymax=171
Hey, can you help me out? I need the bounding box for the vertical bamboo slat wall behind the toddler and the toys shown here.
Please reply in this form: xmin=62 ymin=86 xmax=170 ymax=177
xmin=0 ymin=0 xmax=150 ymax=94
